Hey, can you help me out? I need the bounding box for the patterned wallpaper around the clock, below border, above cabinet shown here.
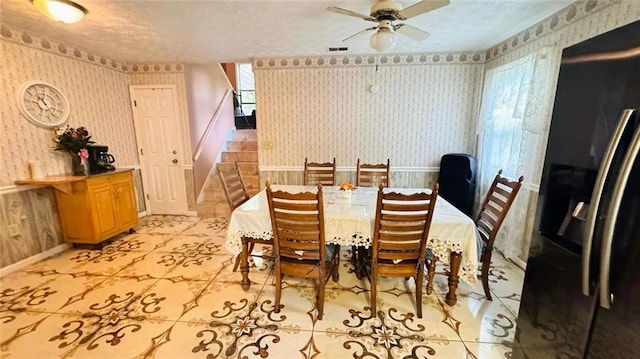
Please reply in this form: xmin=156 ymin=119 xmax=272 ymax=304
xmin=0 ymin=40 xmax=138 ymax=187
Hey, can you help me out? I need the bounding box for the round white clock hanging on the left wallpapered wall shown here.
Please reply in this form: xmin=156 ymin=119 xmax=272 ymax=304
xmin=18 ymin=81 xmax=70 ymax=128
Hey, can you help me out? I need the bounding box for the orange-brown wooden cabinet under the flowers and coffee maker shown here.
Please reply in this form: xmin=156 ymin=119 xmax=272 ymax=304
xmin=56 ymin=170 xmax=138 ymax=243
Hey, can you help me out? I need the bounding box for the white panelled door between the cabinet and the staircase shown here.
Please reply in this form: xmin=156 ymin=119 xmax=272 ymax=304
xmin=130 ymin=85 xmax=187 ymax=214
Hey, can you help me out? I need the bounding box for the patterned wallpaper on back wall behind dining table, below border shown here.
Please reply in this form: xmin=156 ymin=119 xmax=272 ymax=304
xmin=254 ymin=62 xmax=484 ymax=170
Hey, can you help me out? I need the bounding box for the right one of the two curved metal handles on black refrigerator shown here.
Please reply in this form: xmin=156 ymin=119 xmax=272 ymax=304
xmin=600 ymin=112 xmax=640 ymax=309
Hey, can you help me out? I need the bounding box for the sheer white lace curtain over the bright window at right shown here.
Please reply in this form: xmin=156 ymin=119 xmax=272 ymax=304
xmin=478 ymin=48 xmax=552 ymax=260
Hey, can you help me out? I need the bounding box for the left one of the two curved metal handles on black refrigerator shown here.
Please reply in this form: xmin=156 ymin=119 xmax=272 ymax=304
xmin=582 ymin=109 xmax=635 ymax=296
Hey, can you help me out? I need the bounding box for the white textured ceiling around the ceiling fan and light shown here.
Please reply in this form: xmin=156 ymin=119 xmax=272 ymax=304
xmin=0 ymin=0 xmax=575 ymax=63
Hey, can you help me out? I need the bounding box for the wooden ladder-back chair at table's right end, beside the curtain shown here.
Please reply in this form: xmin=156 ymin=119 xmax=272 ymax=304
xmin=475 ymin=170 xmax=524 ymax=300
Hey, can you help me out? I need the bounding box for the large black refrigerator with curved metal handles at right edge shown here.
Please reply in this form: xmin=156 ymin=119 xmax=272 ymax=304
xmin=512 ymin=21 xmax=640 ymax=359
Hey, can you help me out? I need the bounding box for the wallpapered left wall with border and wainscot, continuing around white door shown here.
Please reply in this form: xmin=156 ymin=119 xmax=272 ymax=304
xmin=0 ymin=26 xmax=193 ymax=267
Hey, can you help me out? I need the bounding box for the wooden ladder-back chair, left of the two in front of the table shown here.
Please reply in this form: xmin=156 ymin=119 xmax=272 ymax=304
xmin=266 ymin=182 xmax=340 ymax=320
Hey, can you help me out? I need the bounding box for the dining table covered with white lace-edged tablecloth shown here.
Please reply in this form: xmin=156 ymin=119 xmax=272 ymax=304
xmin=225 ymin=185 xmax=478 ymax=306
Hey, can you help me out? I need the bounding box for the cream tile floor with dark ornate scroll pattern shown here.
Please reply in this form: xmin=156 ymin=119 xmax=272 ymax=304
xmin=0 ymin=216 xmax=524 ymax=359
